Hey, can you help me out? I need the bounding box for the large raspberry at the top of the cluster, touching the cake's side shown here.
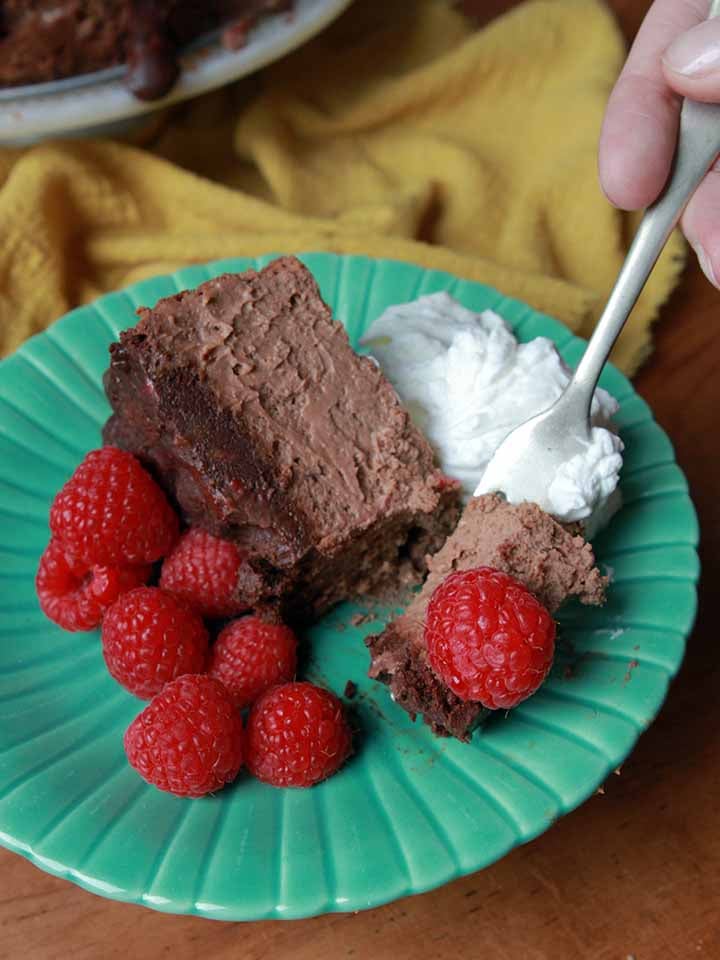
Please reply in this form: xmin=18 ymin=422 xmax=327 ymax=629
xmin=50 ymin=447 xmax=178 ymax=565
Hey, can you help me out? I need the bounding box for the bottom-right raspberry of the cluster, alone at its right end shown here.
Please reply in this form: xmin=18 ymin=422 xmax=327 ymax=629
xmin=245 ymin=683 xmax=352 ymax=787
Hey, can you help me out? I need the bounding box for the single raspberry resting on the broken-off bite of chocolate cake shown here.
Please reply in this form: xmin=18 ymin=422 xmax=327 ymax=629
xmin=425 ymin=567 xmax=555 ymax=710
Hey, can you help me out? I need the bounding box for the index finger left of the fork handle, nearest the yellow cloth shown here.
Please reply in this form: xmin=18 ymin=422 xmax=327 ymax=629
xmin=599 ymin=0 xmax=708 ymax=210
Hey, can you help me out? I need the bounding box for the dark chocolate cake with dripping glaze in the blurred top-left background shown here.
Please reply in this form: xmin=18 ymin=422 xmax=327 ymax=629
xmin=0 ymin=0 xmax=292 ymax=100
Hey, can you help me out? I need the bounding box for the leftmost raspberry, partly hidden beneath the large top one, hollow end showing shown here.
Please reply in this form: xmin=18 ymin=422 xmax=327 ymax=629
xmin=35 ymin=540 xmax=152 ymax=631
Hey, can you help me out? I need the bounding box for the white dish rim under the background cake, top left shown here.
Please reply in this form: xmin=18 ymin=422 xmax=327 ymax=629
xmin=0 ymin=0 xmax=351 ymax=144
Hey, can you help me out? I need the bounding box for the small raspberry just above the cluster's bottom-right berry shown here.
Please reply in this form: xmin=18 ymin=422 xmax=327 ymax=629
xmin=208 ymin=616 xmax=297 ymax=707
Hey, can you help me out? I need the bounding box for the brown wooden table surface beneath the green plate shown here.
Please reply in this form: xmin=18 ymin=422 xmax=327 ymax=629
xmin=0 ymin=0 xmax=720 ymax=960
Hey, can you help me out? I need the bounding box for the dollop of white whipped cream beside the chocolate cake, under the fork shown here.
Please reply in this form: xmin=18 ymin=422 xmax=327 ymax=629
xmin=361 ymin=293 xmax=623 ymax=536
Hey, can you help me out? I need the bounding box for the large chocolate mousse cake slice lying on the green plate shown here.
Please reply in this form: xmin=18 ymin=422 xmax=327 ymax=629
xmin=103 ymin=257 xmax=459 ymax=619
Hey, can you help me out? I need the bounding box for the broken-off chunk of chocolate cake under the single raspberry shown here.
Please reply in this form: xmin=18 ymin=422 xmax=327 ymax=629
xmin=366 ymin=494 xmax=607 ymax=740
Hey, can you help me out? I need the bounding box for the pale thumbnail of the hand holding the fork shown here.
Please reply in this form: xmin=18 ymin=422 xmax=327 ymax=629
xmin=662 ymin=17 xmax=720 ymax=103
